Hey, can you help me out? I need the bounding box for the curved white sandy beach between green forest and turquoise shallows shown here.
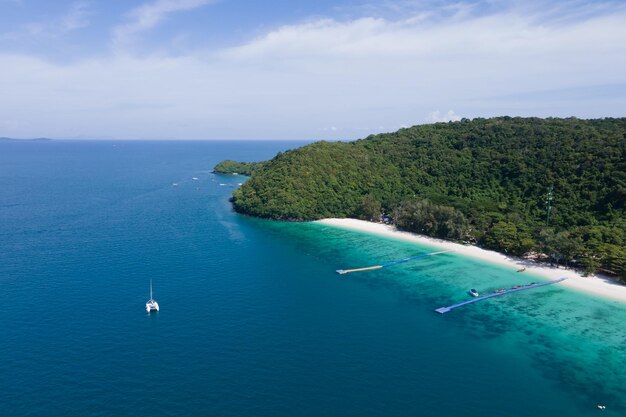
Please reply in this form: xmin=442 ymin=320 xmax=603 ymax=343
xmin=318 ymin=219 xmax=626 ymax=302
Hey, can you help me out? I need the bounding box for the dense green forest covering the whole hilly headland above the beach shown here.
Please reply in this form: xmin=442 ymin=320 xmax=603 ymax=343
xmin=224 ymin=117 xmax=626 ymax=280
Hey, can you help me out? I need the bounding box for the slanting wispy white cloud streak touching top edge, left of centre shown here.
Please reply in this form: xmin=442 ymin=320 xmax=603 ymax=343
xmin=113 ymin=0 xmax=212 ymax=43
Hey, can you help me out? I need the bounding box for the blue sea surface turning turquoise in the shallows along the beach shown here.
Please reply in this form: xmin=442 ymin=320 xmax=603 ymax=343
xmin=0 ymin=141 xmax=626 ymax=417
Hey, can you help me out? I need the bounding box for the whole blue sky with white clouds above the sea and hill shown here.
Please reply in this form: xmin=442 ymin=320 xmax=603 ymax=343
xmin=0 ymin=0 xmax=626 ymax=140
